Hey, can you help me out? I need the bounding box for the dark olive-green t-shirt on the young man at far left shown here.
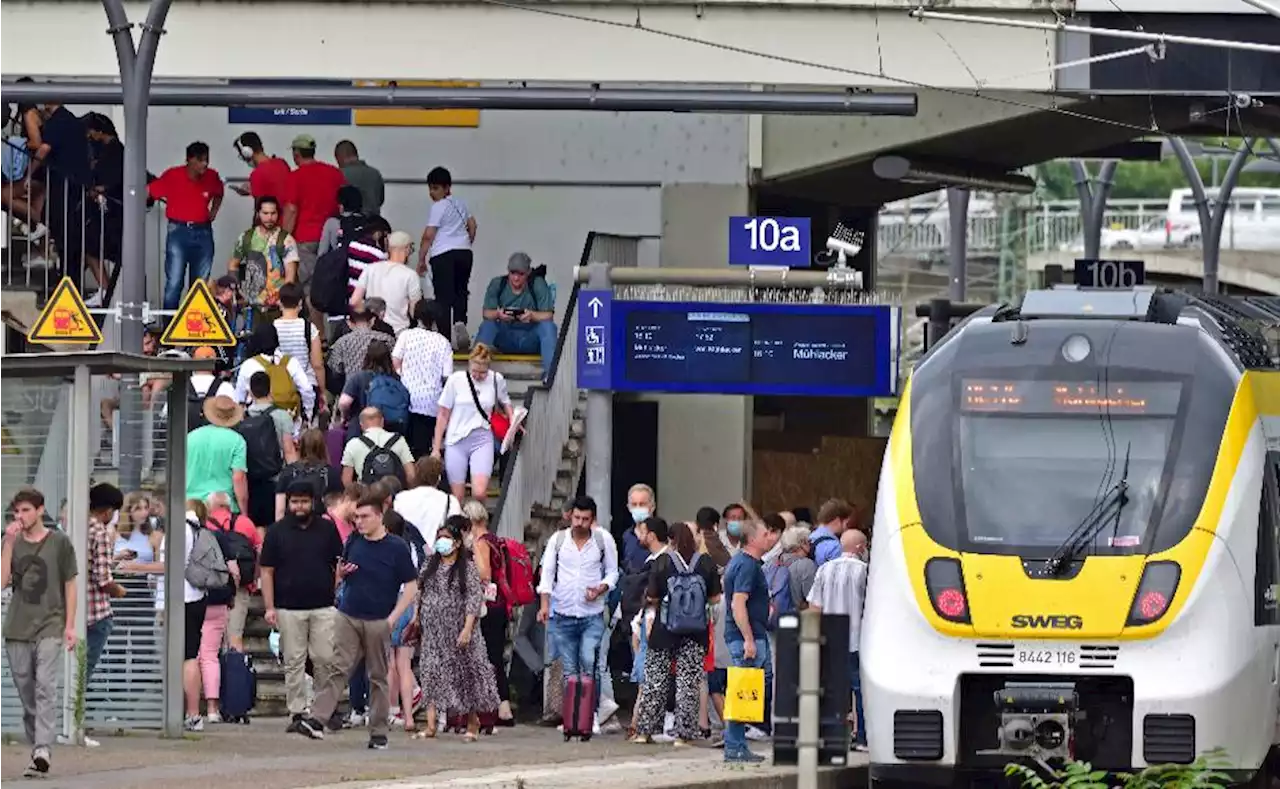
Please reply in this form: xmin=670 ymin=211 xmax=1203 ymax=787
xmin=4 ymin=532 xmax=78 ymax=642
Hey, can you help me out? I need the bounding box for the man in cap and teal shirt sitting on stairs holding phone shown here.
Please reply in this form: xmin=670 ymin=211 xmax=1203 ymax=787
xmin=476 ymin=252 xmax=557 ymax=379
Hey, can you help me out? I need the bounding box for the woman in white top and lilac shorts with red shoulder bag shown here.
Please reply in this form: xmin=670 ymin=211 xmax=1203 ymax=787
xmin=431 ymin=343 xmax=515 ymax=502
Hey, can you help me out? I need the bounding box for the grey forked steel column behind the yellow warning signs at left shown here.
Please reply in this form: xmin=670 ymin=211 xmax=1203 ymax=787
xmin=102 ymin=0 xmax=173 ymax=491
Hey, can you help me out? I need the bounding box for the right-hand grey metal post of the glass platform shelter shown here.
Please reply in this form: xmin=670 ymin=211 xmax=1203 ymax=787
xmin=163 ymin=373 xmax=191 ymax=738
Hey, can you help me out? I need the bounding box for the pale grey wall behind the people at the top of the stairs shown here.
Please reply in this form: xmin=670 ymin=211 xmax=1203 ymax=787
xmin=124 ymin=108 xmax=746 ymax=318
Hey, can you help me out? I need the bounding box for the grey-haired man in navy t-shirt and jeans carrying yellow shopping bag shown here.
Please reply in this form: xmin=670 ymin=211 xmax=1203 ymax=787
xmin=723 ymin=520 xmax=777 ymax=763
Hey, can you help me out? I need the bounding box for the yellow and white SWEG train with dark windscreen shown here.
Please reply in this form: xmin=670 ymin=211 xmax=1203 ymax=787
xmin=860 ymin=287 xmax=1280 ymax=786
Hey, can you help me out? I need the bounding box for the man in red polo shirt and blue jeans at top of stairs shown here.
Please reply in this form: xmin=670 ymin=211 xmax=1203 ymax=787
xmin=147 ymin=142 xmax=223 ymax=310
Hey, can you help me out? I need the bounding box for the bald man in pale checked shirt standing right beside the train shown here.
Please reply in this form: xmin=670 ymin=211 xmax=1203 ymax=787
xmin=809 ymin=529 xmax=867 ymax=751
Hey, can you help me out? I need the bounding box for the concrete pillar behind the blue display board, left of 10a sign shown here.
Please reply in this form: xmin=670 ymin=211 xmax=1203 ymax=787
xmin=640 ymin=183 xmax=751 ymax=520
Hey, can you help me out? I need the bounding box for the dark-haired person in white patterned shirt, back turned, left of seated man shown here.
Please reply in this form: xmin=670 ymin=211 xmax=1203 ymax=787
xmin=392 ymin=300 xmax=453 ymax=458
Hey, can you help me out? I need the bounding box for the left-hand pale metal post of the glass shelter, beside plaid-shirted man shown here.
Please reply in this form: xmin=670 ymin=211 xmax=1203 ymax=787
xmin=63 ymin=365 xmax=95 ymax=745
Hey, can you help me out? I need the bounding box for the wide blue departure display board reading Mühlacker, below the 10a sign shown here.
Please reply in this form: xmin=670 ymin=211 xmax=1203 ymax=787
xmin=579 ymin=300 xmax=900 ymax=397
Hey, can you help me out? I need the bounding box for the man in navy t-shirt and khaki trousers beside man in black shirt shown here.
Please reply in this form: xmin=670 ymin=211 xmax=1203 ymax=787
xmin=303 ymin=493 xmax=417 ymax=751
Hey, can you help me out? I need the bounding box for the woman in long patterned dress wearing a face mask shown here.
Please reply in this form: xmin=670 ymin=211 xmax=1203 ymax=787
xmin=417 ymin=515 xmax=499 ymax=743
